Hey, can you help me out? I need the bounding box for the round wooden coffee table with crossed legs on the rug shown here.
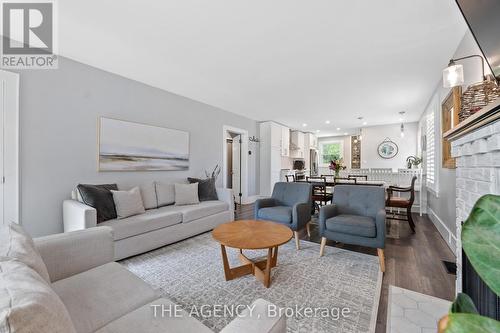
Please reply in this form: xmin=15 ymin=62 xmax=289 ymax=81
xmin=212 ymin=220 xmax=293 ymax=288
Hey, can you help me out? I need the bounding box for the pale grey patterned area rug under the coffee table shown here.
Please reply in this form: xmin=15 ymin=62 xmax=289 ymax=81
xmin=121 ymin=233 xmax=382 ymax=333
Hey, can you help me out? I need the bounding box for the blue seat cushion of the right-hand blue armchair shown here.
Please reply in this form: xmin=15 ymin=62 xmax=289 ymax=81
xmin=326 ymin=214 xmax=377 ymax=237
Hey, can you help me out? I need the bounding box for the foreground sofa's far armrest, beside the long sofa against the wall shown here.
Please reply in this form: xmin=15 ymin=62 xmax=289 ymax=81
xmin=34 ymin=227 xmax=115 ymax=282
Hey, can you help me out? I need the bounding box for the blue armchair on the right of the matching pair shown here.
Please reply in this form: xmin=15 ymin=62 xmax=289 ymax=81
xmin=319 ymin=185 xmax=385 ymax=272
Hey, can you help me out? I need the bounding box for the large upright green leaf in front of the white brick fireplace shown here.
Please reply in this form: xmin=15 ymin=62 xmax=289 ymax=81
xmin=462 ymin=194 xmax=500 ymax=295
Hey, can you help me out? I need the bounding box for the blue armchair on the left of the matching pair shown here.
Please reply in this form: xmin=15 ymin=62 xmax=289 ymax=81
xmin=255 ymin=182 xmax=312 ymax=250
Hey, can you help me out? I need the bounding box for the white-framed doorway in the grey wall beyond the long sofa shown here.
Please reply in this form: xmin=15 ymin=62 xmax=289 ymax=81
xmin=223 ymin=126 xmax=248 ymax=205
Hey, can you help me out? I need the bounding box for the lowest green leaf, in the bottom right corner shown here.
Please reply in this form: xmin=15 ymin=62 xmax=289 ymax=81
xmin=444 ymin=313 xmax=500 ymax=333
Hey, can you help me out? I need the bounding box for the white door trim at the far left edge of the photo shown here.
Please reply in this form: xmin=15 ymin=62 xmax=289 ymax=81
xmin=0 ymin=70 xmax=19 ymax=225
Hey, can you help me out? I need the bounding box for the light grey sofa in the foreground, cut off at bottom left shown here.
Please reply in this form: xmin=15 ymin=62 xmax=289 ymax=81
xmin=0 ymin=225 xmax=286 ymax=333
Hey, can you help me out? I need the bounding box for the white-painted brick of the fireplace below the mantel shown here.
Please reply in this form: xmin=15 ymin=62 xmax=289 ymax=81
xmin=451 ymin=121 xmax=500 ymax=293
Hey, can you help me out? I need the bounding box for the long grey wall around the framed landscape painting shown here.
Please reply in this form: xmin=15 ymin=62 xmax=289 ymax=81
xmin=14 ymin=58 xmax=258 ymax=236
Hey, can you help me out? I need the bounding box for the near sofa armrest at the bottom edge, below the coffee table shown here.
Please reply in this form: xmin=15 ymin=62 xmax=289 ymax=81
xmin=221 ymin=299 xmax=286 ymax=333
